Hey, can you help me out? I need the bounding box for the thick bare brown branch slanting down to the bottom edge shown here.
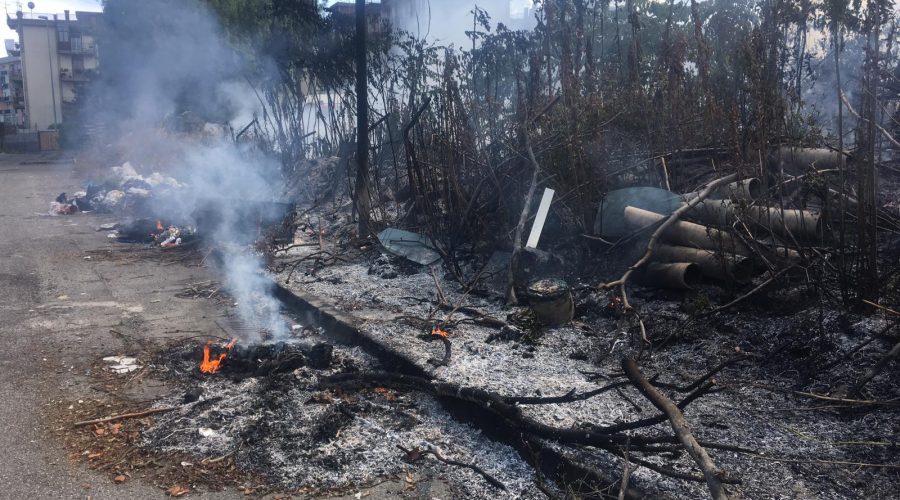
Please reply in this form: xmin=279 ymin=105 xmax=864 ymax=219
xmin=622 ymin=359 xmax=728 ymax=500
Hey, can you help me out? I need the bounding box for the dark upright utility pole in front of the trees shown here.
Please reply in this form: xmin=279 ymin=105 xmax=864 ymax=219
xmin=354 ymin=0 xmax=371 ymax=238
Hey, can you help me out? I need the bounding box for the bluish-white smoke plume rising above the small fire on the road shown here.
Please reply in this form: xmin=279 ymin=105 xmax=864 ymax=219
xmin=92 ymin=0 xmax=288 ymax=340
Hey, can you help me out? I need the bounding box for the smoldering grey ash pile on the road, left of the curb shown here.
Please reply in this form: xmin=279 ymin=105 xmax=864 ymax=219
xmin=143 ymin=340 xmax=542 ymax=498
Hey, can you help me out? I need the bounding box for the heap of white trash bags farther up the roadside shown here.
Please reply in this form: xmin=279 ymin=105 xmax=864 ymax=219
xmin=49 ymin=162 xmax=184 ymax=215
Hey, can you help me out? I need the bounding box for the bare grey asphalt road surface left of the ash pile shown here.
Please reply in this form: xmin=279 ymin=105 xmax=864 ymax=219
xmin=0 ymin=155 xmax=240 ymax=499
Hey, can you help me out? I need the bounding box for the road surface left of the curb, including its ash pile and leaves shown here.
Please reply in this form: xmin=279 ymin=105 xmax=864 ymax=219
xmin=0 ymin=156 xmax=541 ymax=498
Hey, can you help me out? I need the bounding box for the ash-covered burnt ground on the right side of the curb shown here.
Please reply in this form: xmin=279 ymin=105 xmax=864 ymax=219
xmin=274 ymin=213 xmax=900 ymax=499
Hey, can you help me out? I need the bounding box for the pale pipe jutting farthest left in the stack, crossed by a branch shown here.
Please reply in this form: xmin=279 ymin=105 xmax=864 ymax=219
xmin=625 ymin=207 xmax=753 ymax=257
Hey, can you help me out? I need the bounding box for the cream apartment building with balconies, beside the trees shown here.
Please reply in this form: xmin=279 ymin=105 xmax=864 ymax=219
xmin=6 ymin=11 xmax=102 ymax=130
